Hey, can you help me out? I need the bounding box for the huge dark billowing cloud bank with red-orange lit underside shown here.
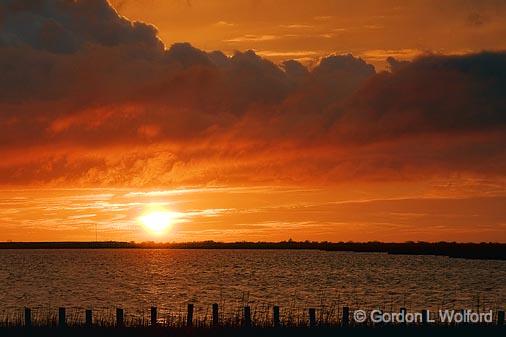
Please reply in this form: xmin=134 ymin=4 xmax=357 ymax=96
xmin=0 ymin=0 xmax=506 ymax=186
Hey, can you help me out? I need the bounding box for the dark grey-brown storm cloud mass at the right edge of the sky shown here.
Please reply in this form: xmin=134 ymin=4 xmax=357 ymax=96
xmin=337 ymin=52 xmax=506 ymax=141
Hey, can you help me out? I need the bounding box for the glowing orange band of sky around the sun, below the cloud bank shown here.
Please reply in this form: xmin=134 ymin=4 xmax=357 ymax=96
xmin=0 ymin=185 xmax=506 ymax=242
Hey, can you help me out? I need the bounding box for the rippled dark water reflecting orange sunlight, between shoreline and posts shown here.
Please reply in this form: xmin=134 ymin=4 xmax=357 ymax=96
xmin=0 ymin=249 xmax=506 ymax=317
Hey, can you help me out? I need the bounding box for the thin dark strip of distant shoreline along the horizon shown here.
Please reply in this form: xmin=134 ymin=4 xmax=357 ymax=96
xmin=0 ymin=240 xmax=506 ymax=260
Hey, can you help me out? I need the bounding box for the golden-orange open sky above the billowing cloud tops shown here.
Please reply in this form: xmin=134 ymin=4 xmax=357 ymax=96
xmin=111 ymin=0 xmax=506 ymax=68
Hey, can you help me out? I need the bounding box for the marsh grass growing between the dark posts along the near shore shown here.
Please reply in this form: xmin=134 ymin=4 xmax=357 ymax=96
xmin=0 ymin=302 xmax=498 ymax=329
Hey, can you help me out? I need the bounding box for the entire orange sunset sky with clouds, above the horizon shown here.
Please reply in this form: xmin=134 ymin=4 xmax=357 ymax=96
xmin=0 ymin=0 xmax=506 ymax=242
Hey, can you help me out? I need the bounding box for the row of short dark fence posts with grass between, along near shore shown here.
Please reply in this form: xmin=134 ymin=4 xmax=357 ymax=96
xmin=0 ymin=303 xmax=505 ymax=328
